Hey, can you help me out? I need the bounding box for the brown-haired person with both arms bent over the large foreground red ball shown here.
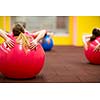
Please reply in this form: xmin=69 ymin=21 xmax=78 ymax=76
xmin=0 ymin=23 xmax=46 ymax=50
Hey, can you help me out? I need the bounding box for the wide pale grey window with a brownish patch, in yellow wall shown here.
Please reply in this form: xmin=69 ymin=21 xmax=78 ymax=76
xmin=11 ymin=16 xmax=68 ymax=34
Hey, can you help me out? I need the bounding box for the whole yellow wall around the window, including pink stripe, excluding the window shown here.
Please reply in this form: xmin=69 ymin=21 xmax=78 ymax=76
xmin=0 ymin=16 xmax=100 ymax=46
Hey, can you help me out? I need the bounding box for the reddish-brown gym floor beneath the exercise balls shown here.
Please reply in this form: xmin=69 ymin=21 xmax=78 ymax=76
xmin=0 ymin=46 xmax=100 ymax=83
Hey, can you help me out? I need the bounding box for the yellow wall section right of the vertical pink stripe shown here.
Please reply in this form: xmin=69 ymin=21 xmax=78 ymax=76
xmin=76 ymin=16 xmax=100 ymax=46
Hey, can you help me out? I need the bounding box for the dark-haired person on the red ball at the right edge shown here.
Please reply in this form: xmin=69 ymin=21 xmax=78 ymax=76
xmin=83 ymin=28 xmax=100 ymax=51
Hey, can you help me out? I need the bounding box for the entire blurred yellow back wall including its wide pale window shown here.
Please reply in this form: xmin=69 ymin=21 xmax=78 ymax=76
xmin=0 ymin=16 xmax=100 ymax=46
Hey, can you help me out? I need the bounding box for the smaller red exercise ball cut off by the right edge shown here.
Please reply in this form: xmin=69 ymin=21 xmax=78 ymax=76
xmin=84 ymin=37 xmax=100 ymax=64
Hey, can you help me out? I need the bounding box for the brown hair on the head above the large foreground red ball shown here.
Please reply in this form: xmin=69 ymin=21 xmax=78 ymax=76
xmin=12 ymin=23 xmax=25 ymax=36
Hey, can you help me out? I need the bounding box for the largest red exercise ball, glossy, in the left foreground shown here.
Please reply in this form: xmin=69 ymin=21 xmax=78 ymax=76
xmin=0 ymin=36 xmax=45 ymax=79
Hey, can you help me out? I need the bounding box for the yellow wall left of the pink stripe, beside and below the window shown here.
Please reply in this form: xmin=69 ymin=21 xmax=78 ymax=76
xmin=0 ymin=16 xmax=73 ymax=45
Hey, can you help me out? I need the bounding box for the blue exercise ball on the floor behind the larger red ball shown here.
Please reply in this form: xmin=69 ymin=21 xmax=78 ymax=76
xmin=41 ymin=35 xmax=53 ymax=51
